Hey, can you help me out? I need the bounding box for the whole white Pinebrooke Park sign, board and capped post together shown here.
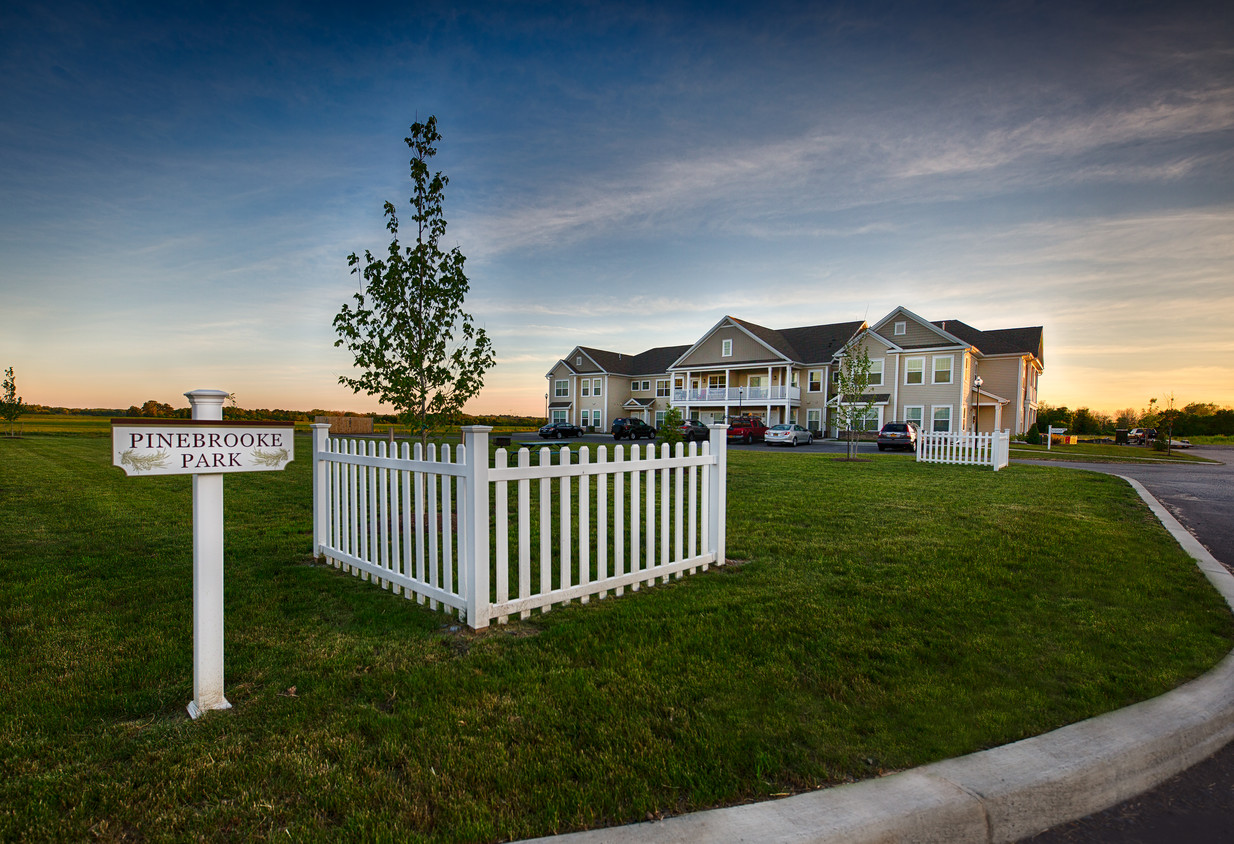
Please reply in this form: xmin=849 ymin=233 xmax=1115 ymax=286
xmin=111 ymin=390 xmax=295 ymax=718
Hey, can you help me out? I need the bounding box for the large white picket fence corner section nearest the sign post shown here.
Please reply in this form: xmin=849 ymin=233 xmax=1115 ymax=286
xmin=312 ymin=424 xmax=727 ymax=629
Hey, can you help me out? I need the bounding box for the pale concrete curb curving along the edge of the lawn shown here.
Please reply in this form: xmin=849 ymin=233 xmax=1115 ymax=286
xmin=525 ymin=475 xmax=1234 ymax=844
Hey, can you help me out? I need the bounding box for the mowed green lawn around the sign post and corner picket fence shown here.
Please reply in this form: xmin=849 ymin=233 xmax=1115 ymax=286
xmin=0 ymin=437 xmax=1234 ymax=842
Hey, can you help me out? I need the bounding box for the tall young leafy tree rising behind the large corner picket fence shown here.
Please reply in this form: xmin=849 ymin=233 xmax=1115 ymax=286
xmin=334 ymin=116 xmax=496 ymax=445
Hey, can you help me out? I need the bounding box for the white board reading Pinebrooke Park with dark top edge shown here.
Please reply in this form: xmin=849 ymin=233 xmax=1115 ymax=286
xmin=111 ymin=420 xmax=295 ymax=475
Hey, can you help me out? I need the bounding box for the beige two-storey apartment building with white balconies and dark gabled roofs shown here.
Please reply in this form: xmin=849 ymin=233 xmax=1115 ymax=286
xmin=545 ymin=307 xmax=1044 ymax=436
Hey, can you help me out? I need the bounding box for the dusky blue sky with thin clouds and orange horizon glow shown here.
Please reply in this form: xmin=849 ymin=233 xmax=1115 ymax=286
xmin=0 ymin=2 xmax=1234 ymax=413
